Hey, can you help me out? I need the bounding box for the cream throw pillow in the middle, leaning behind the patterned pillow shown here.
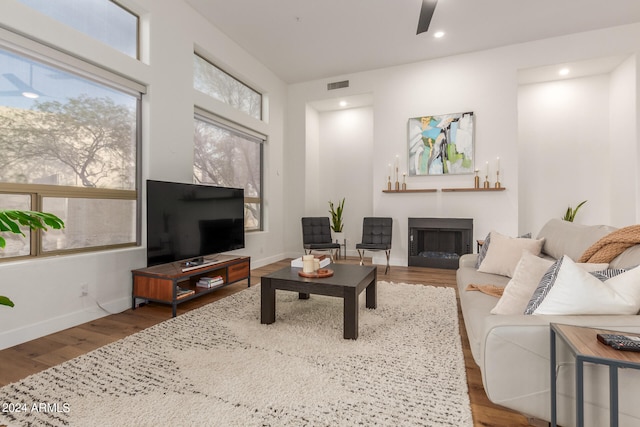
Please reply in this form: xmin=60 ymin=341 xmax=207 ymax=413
xmin=491 ymin=250 xmax=553 ymax=314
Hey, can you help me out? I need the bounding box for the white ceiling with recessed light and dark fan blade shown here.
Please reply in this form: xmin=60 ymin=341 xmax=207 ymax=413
xmin=186 ymin=0 xmax=640 ymax=83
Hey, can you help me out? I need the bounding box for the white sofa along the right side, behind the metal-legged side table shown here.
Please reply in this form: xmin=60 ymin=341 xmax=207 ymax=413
xmin=457 ymin=220 xmax=640 ymax=426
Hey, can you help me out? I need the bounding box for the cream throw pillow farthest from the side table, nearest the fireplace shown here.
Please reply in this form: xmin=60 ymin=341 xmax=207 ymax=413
xmin=478 ymin=231 xmax=544 ymax=277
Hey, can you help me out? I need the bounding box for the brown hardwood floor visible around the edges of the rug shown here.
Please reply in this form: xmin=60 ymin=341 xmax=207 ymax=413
xmin=0 ymin=258 xmax=530 ymax=427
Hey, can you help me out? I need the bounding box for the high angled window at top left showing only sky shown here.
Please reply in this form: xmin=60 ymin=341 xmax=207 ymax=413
xmin=18 ymin=0 xmax=139 ymax=58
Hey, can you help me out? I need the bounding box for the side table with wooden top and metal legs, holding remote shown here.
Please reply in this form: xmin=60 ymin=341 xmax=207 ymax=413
xmin=549 ymin=323 xmax=640 ymax=427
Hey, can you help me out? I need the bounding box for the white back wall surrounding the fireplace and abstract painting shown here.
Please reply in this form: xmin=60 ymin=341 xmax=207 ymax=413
xmin=285 ymin=24 xmax=640 ymax=265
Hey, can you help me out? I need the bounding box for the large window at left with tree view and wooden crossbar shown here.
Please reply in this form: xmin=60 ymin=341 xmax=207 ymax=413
xmin=0 ymin=41 xmax=144 ymax=259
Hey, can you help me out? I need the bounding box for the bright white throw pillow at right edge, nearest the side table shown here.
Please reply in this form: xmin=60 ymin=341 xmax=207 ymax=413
xmin=533 ymin=255 xmax=640 ymax=315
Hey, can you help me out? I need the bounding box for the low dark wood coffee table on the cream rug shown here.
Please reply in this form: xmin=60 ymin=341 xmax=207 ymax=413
xmin=260 ymin=264 xmax=378 ymax=340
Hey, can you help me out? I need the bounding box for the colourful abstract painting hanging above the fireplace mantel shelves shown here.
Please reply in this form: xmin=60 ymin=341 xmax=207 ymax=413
xmin=408 ymin=112 xmax=474 ymax=176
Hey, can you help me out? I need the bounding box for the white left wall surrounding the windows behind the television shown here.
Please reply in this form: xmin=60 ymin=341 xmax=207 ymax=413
xmin=0 ymin=0 xmax=286 ymax=348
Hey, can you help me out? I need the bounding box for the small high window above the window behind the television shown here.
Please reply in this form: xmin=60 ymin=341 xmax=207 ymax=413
xmin=193 ymin=54 xmax=262 ymax=120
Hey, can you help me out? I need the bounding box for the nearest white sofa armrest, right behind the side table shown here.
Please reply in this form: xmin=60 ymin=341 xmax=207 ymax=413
xmin=479 ymin=315 xmax=640 ymax=425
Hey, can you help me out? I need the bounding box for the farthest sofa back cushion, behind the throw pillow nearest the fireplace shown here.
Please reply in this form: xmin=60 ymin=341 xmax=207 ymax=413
xmin=537 ymin=218 xmax=616 ymax=259
